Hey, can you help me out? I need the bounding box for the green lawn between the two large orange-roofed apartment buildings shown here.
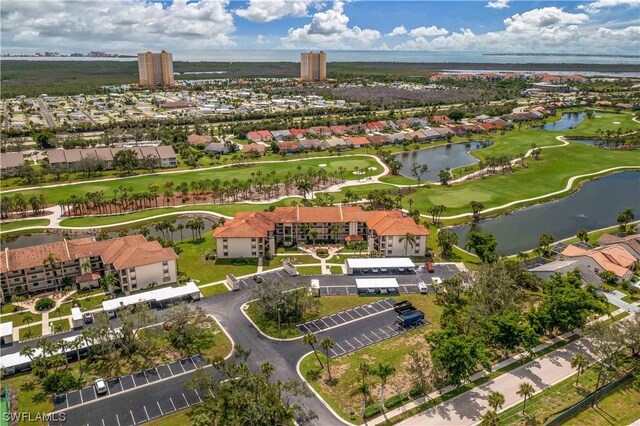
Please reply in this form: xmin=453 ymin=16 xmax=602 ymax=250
xmin=177 ymin=232 xmax=258 ymax=284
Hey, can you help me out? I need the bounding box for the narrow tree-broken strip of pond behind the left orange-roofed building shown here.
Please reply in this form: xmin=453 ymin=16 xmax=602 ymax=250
xmin=2 ymin=218 xmax=218 ymax=250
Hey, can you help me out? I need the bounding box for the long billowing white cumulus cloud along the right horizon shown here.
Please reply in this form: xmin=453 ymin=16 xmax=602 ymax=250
xmin=393 ymin=7 xmax=640 ymax=53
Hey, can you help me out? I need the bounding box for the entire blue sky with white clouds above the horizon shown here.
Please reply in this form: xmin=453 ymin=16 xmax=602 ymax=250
xmin=0 ymin=0 xmax=640 ymax=56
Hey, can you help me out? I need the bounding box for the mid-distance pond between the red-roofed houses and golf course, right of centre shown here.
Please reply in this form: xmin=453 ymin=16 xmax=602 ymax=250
xmin=395 ymin=141 xmax=492 ymax=182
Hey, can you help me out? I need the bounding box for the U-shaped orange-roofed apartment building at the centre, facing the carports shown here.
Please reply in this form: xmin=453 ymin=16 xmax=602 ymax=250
xmin=213 ymin=205 xmax=429 ymax=258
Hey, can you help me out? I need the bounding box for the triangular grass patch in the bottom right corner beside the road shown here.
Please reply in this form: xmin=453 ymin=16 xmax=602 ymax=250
xmin=565 ymin=383 xmax=640 ymax=426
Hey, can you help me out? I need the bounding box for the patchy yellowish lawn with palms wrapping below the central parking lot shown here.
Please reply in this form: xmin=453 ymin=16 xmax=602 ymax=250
xmin=300 ymin=294 xmax=441 ymax=423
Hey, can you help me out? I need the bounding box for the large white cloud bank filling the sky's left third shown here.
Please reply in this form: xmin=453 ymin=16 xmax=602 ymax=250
xmin=1 ymin=0 xmax=235 ymax=52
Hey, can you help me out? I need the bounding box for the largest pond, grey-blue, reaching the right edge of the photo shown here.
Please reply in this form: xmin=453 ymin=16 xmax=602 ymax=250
xmin=452 ymin=172 xmax=640 ymax=255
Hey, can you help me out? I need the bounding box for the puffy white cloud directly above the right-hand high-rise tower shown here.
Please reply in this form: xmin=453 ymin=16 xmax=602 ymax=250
xmin=281 ymin=1 xmax=380 ymax=49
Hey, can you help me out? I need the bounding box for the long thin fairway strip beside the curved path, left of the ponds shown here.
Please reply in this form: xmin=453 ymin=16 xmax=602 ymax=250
xmin=6 ymin=156 xmax=382 ymax=203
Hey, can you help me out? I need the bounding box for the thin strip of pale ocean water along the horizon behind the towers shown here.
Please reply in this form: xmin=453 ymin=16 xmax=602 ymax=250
xmin=2 ymin=50 xmax=638 ymax=65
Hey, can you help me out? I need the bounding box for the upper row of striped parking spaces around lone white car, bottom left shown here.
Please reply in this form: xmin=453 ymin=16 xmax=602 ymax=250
xmin=53 ymin=355 xmax=206 ymax=411
